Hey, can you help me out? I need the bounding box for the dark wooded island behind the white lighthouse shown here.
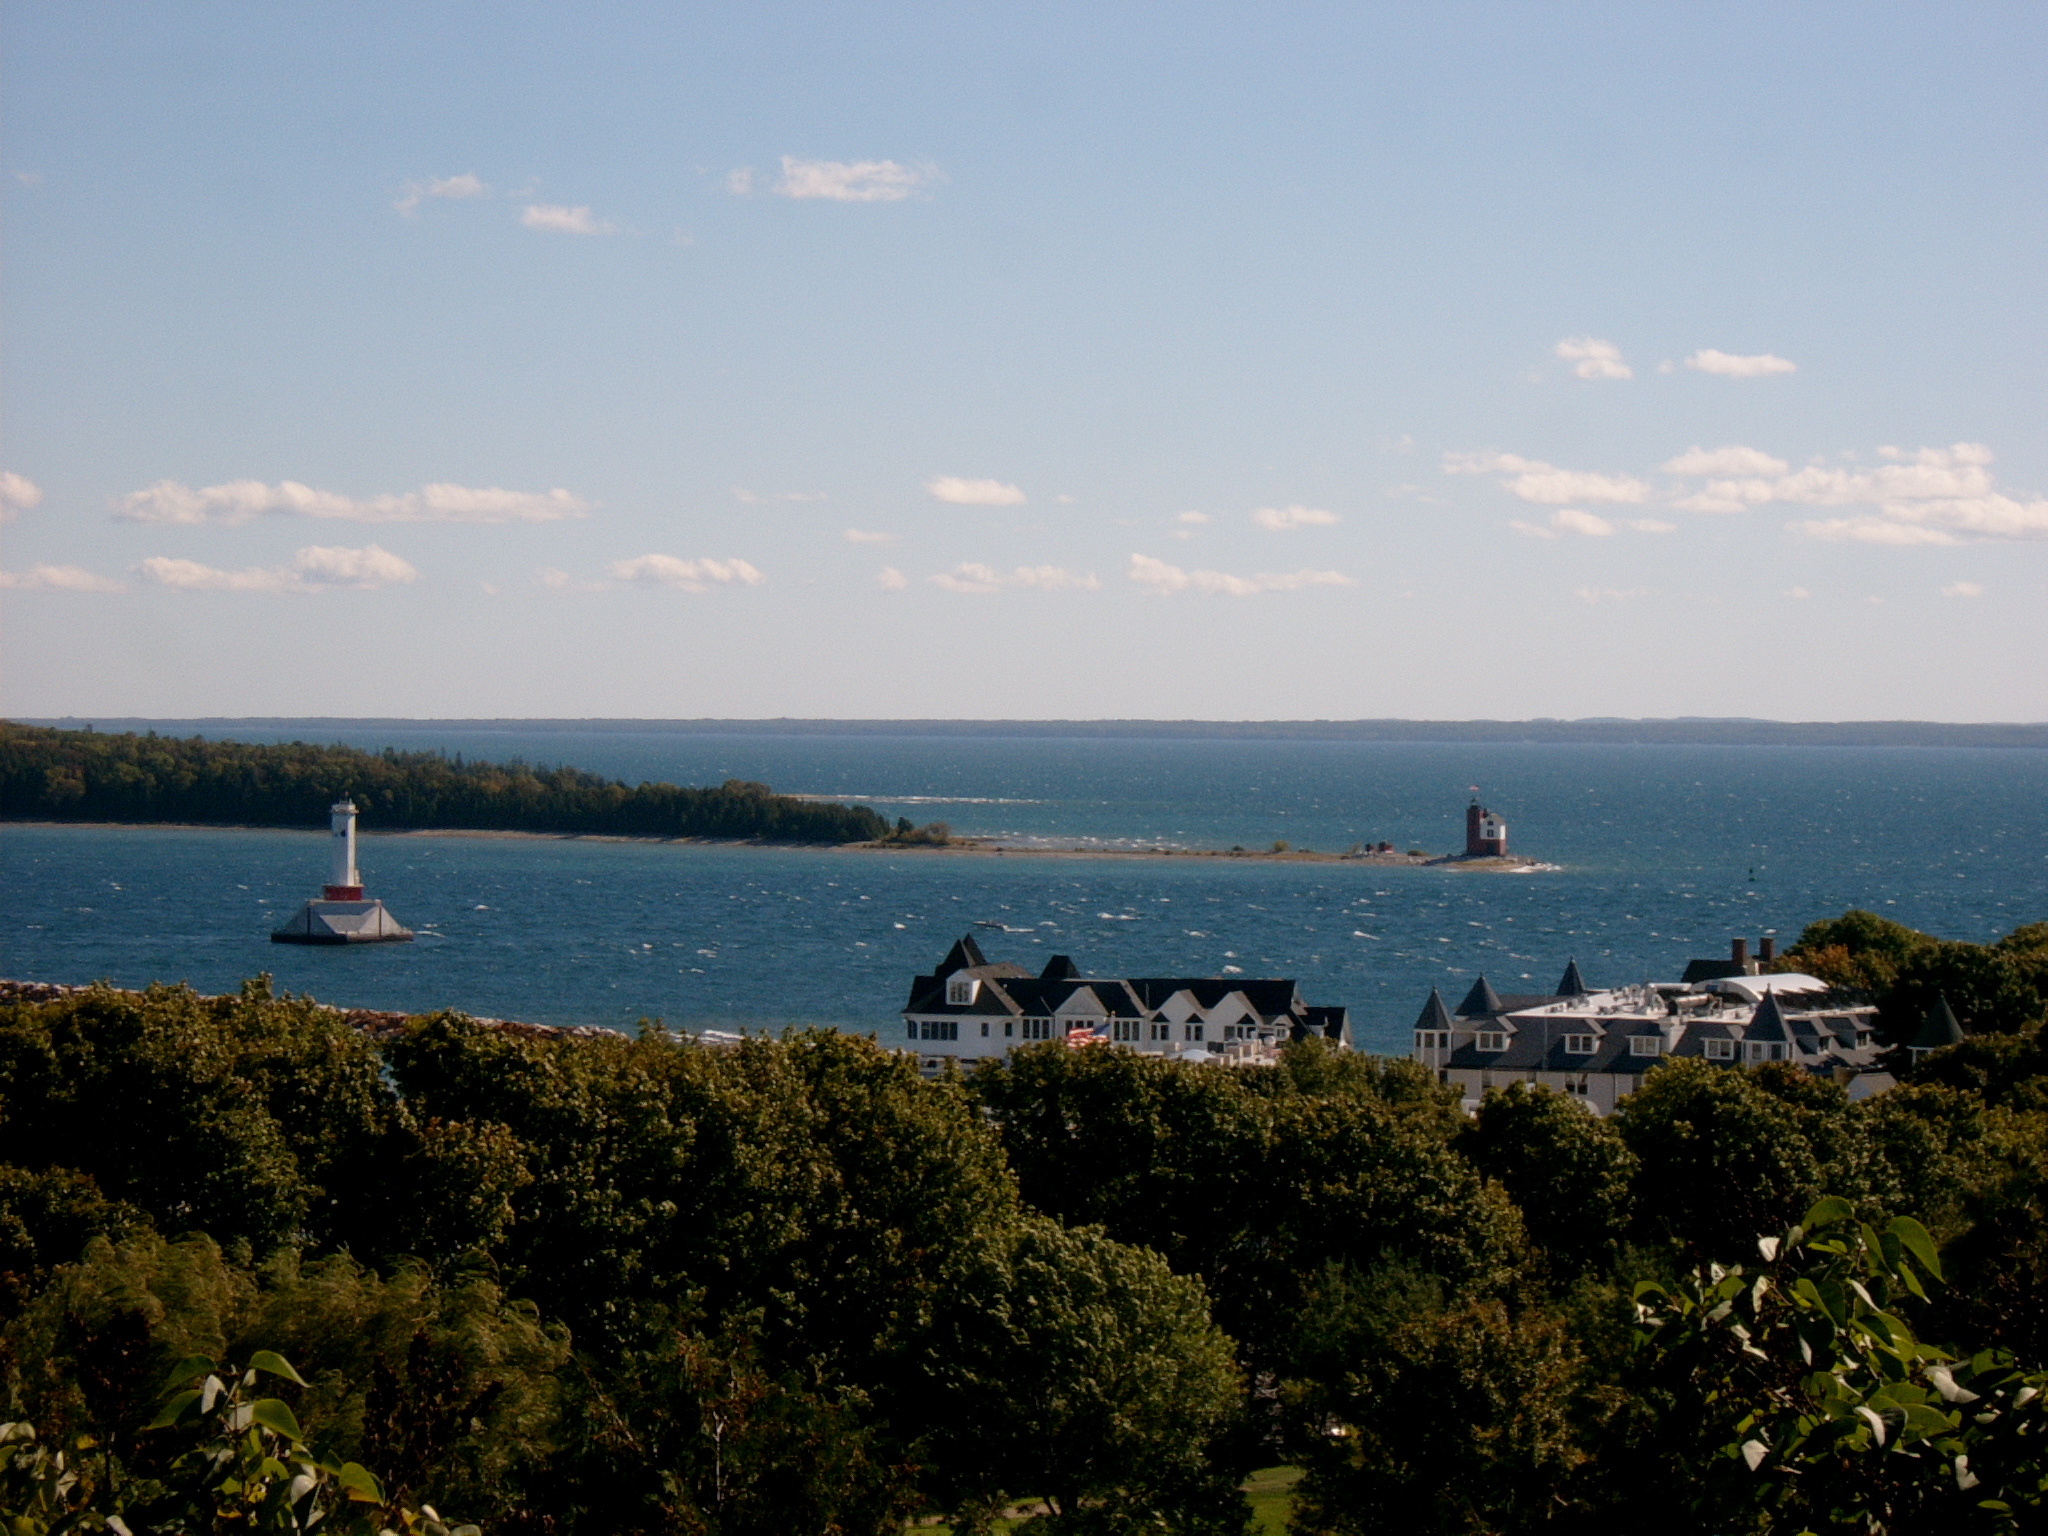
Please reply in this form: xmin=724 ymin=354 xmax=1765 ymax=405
xmin=0 ymin=723 xmax=891 ymax=844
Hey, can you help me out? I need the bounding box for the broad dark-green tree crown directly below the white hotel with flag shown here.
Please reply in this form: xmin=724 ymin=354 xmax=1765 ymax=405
xmin=971 ymin=1042 xmax=1522 ymax=1354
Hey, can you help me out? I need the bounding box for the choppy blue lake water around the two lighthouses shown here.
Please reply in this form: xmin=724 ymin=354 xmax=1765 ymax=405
xmin=0 ymin=723 xmax=2048 ymax=1051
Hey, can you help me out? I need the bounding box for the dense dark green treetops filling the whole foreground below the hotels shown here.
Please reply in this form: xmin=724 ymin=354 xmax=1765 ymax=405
xmin=0 ymin=913 xmax=2048 ymax=1536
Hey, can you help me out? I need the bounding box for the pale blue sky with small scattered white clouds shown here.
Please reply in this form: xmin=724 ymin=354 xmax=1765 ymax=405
xmin=0 ymin=0 xmax=2048 ymax=721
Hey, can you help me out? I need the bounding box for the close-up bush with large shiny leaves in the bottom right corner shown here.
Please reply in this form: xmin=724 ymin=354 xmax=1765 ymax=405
xmin=1636 ymin=1196 xmax=2048 ymax=1532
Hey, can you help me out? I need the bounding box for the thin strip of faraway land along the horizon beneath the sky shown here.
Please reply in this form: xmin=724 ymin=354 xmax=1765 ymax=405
xmin=10 ymin=715 xmax=2048 ymax=750
